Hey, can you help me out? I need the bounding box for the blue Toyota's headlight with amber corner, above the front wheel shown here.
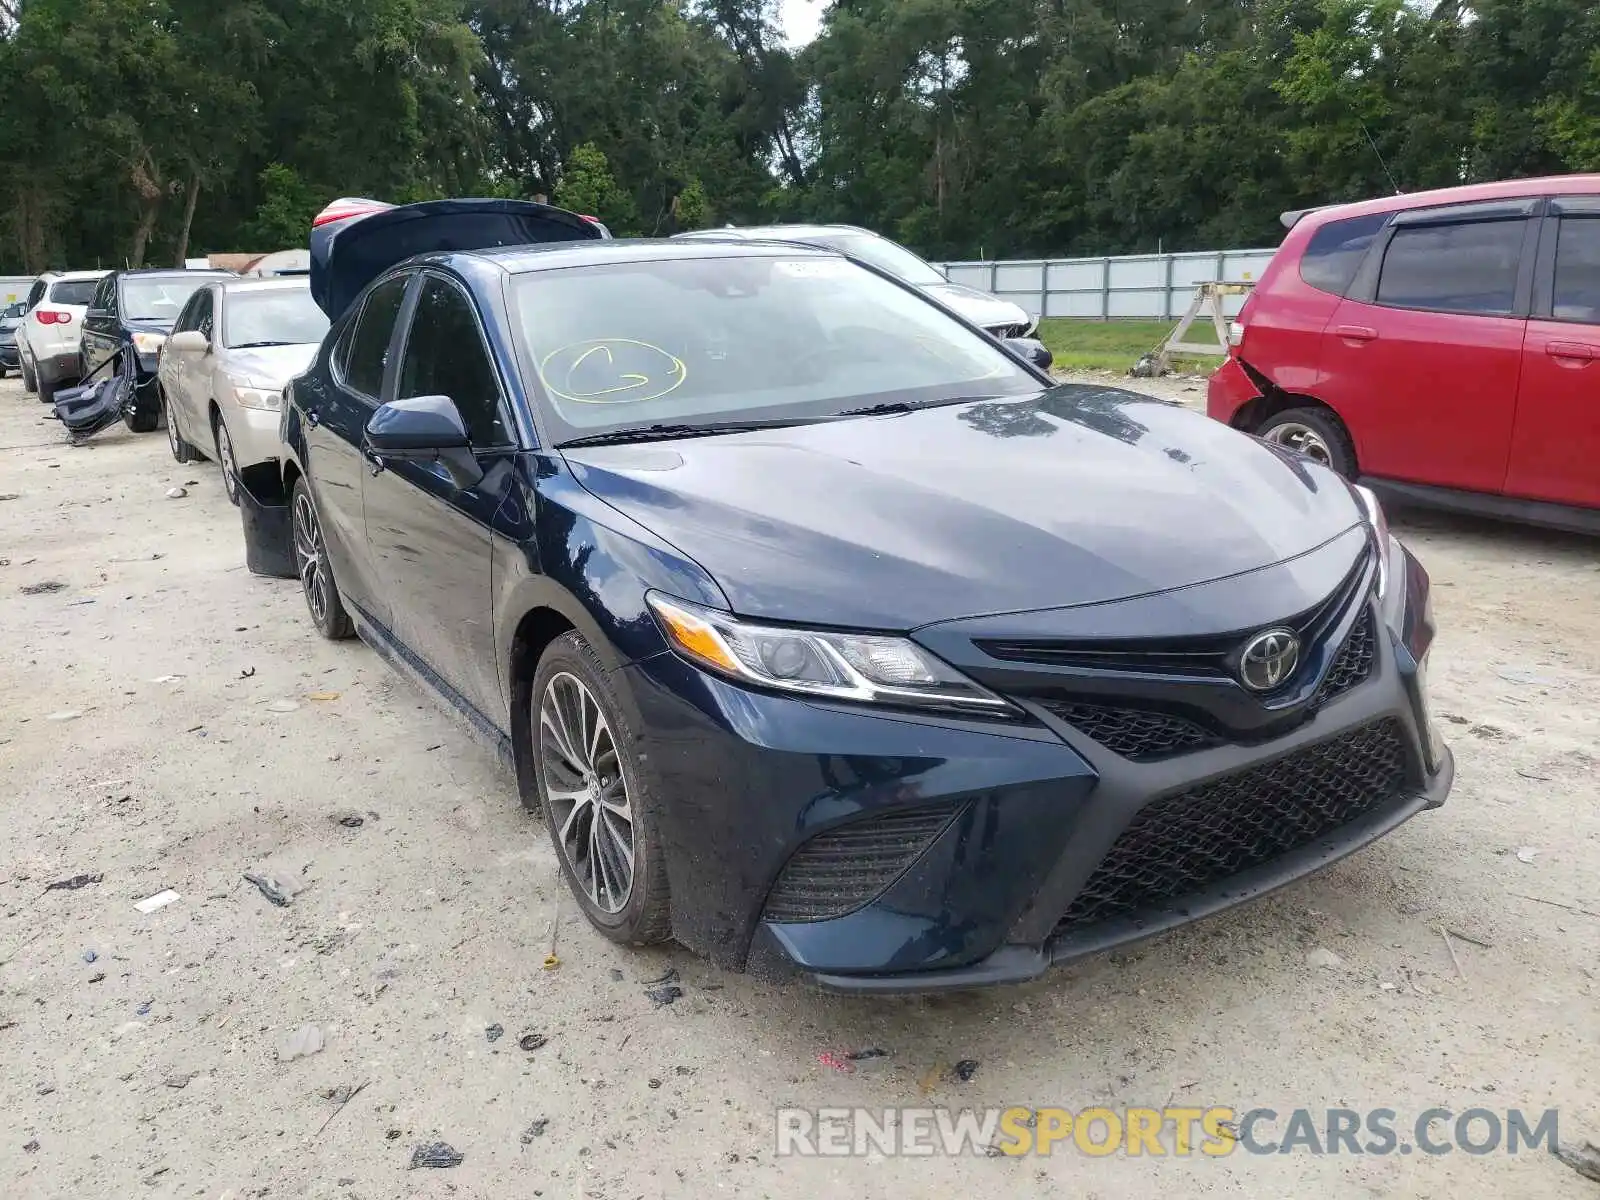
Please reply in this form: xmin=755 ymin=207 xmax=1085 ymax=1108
xmin=646 ymin=592 xmax=1016 ymax=715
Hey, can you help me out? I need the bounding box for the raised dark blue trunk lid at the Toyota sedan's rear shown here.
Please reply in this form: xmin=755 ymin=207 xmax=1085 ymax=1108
xmin=310 ymin=200 xmax=610 ymax=320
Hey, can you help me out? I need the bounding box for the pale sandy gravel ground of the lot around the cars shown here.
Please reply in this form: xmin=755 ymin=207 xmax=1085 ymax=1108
xmin=0 ymin=371 xmax=1600 ymax=1200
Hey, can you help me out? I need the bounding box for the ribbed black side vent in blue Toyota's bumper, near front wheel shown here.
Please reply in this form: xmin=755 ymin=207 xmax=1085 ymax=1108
xmin=763 ymin=805 xmax=957 ymax=922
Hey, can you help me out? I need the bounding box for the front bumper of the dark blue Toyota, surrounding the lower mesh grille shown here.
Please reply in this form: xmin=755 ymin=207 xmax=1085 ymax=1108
xmin=619 ymin=540 xmax=1454 ymax=992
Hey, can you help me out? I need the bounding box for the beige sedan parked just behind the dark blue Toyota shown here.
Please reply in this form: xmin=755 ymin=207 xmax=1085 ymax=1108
xmin=155 ymin=275 xmax=328 ymax=504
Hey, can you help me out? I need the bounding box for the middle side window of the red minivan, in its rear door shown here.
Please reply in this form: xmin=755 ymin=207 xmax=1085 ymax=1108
xmin=1378 ymin=219 xmax=1528 ymax=317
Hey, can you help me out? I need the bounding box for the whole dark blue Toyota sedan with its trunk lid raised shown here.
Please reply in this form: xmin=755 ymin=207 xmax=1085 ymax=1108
xmin=256 ymin=200 xmax=1453 ymax=990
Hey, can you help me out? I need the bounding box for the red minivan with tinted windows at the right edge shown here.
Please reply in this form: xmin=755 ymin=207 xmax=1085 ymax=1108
xmin=1208 ymin=174 xmax=1600 ymax=533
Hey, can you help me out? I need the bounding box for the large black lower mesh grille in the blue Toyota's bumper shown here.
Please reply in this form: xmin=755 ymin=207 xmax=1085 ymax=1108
xmin=1056 ymin=718 xmax=1406 ymax=933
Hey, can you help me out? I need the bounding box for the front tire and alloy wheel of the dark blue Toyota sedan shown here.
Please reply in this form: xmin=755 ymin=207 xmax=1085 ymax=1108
xmin=528 ymin=632 xmax=672 ymax=946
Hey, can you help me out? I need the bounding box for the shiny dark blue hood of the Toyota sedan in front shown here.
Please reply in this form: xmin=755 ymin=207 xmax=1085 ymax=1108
xmin=563 ymin=384 xmax=1362 ymax=630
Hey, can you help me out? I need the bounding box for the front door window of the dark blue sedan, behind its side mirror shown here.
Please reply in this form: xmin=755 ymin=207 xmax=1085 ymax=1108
xmin=395 ymin=275 xmax=510 ymax=446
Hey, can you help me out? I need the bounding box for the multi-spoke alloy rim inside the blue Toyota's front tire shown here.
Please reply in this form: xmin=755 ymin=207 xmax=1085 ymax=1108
xmin=539 ymin=672 xmax=635 ymax=914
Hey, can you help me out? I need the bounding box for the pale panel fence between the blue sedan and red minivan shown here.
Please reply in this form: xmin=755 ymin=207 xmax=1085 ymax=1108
xmin=939 ymin=250 xmax=1274 ymax=322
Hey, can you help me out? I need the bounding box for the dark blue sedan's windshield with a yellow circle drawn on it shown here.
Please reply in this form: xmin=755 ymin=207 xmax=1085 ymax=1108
xmin=512 ymin=254 xmax=1040 ymax=443
